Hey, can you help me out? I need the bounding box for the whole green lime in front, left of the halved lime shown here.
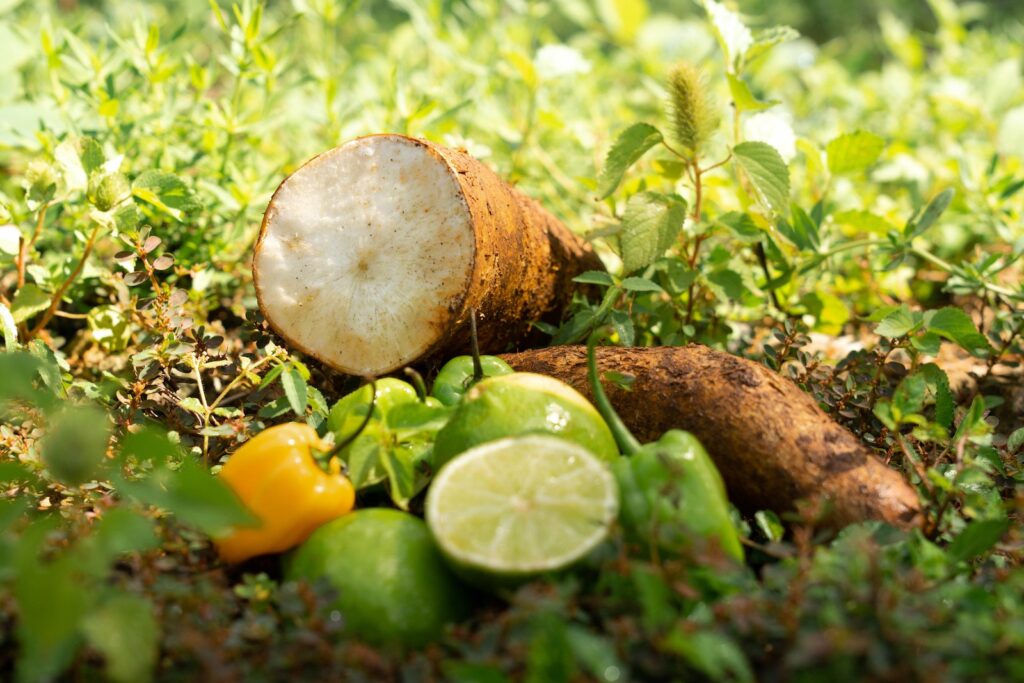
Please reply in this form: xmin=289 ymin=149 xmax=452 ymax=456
xmin=285 ymin=508 xmax=470 ymax=647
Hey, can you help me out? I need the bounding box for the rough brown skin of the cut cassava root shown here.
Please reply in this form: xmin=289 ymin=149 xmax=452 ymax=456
xmin=253 ymin=134 xmax=605 ymax=373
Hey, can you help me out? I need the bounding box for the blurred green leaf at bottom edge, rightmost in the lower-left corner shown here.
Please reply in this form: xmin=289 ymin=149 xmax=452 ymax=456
xmin=82 ymin=593 xmax=160 ymax=683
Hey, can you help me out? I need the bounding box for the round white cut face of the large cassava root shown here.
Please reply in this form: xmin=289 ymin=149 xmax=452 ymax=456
xmin=254 ymin=136 xmax=473 ymax=375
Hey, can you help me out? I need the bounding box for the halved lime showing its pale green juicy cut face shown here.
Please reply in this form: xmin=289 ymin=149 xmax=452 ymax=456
xmin=426 ymin=434 xmax=618 ymax=586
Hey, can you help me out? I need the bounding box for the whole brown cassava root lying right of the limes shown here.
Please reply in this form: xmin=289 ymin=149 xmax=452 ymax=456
xmin=502 ymin=345 xmax=922 ymax=528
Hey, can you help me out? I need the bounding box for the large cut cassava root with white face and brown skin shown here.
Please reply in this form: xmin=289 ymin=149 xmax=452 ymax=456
xmin=253 ymin=135 xmax=604 ymax=376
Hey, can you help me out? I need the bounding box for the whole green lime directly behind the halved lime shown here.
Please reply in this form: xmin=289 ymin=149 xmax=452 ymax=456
xmin=434 ymin=373 xmax=618 ymax=467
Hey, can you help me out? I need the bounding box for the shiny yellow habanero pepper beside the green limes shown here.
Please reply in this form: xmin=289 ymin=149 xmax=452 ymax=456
xmin=214 ymin=422 xmax=355 ymax=563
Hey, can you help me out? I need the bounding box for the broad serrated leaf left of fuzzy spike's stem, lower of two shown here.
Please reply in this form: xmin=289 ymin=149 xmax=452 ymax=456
xmin=618 ymin=193 xmax=686 ymax=272
